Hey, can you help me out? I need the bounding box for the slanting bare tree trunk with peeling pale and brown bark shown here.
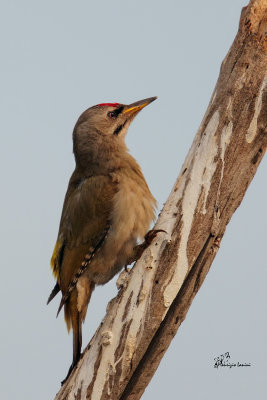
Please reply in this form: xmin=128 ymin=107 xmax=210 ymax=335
xmin=56 ymin=0 xmax=267 ymax=400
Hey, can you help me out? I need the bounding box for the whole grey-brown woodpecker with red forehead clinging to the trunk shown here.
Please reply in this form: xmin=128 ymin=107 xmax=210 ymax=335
xmin=47 ymin=97 xmax=158 ymax=377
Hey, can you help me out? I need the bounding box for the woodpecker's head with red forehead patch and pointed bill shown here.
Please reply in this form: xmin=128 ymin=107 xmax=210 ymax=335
xmin=73 ymin=97 xmax=157 ymax=171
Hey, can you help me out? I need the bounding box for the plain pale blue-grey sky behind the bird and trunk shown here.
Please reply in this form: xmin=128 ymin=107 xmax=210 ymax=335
xmin=0 ymin=0 xmax=267 ymax=400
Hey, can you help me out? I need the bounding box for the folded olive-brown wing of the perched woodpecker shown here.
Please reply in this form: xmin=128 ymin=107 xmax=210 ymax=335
xmin=49 ymin=172 xmax=117 ymax=301
